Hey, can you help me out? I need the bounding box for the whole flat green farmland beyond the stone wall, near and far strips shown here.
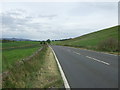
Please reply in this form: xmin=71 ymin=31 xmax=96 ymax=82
xmin=2 ymin=41 xmax=41 ymax=71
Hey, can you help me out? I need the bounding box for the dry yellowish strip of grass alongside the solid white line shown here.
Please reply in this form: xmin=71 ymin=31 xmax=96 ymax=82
xmin=35 ymin=48 xmax=63 ymax=88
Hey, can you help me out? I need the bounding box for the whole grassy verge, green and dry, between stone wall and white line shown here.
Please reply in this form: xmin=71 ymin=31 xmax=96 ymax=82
xmin=2 ymin=46 xmax=63 ymax=88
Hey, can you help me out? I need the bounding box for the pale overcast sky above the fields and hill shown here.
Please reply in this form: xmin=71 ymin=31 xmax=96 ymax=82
xmin=0 ymin=2 xmax=118 ymax=40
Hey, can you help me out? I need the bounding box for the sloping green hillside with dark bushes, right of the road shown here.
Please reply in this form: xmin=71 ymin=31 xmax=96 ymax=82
xmin=53 ymin=26 xmax=118 ymax=52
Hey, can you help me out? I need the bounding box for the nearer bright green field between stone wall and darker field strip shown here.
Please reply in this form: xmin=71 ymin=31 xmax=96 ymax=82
xmin=2 ymin=46 xmax=40 ymax=71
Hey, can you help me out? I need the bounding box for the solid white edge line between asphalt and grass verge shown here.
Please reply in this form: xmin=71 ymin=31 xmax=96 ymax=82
xmin=49 ymin=46 xmax=70 ymax=90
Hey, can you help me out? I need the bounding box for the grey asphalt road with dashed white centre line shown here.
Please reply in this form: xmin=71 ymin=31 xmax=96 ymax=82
xmin=51 ymin=46 xmax=118 ymax=88
